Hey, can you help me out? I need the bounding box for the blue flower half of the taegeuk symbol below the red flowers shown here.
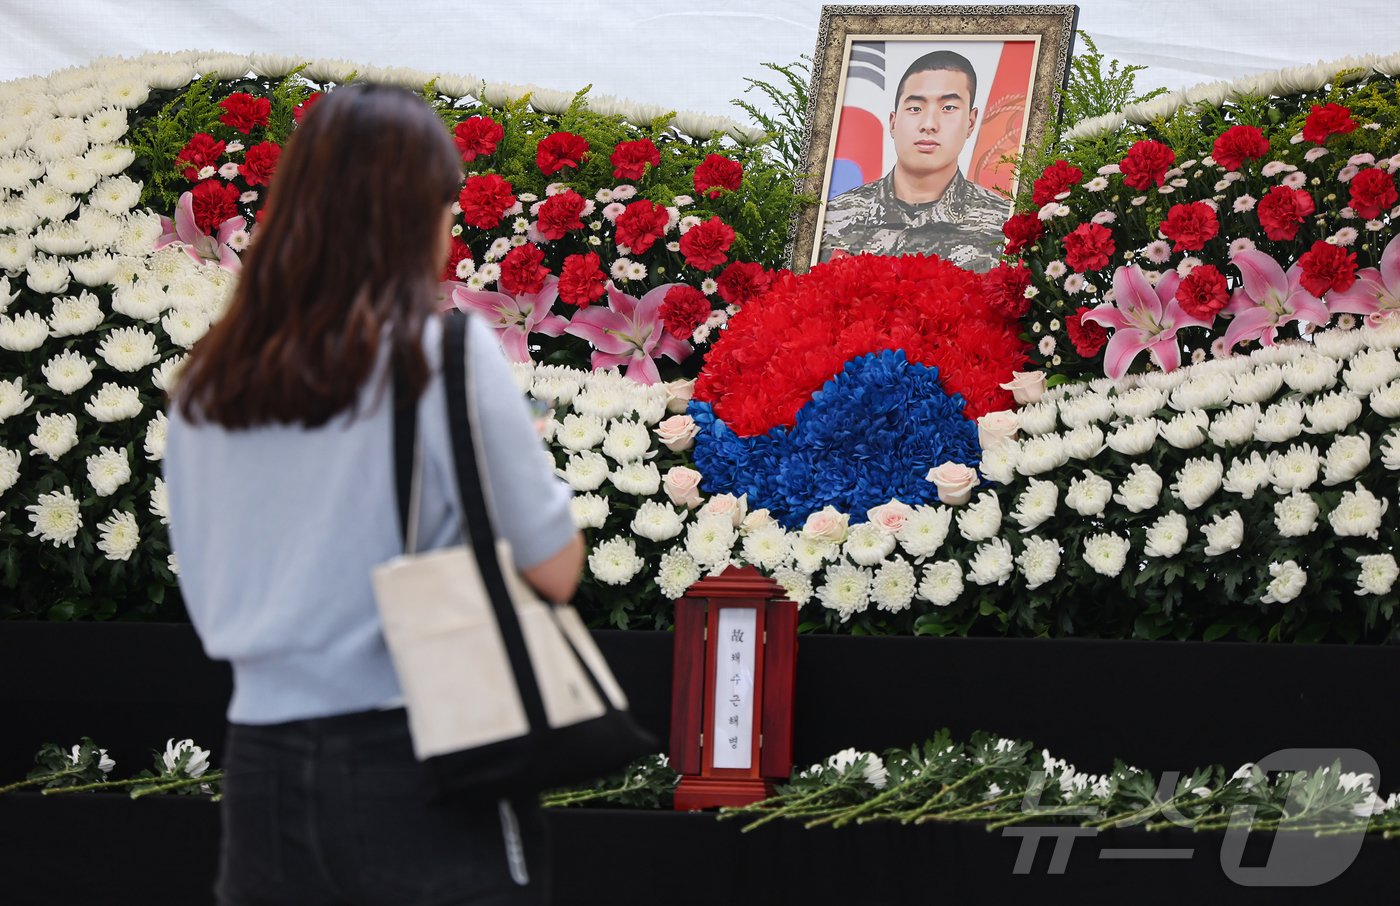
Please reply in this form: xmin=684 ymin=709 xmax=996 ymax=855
xmin=689 ymin=349 xmax=981 ymax=528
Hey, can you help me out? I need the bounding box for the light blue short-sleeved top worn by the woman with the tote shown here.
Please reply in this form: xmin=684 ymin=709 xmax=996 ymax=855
xmin=164 ymin=318 xmax=574 ymax=724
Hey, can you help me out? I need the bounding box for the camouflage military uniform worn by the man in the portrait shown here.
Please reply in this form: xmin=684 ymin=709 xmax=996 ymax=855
xmin=822 ymin=171 xmax=1011 ymax=272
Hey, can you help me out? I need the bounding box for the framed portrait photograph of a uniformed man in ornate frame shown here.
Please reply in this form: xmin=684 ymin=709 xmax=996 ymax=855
xmin=792 ymin=6 xmax=1078 ymax=272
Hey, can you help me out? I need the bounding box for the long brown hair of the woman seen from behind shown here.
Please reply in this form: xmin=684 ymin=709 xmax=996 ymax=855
xmin=178 ymin=84 xmax=462 ymax=428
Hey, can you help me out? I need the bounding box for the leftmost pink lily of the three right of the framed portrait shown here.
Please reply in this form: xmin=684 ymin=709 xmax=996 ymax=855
xmin=1084 ymin=265 xmax=1210 ymax=379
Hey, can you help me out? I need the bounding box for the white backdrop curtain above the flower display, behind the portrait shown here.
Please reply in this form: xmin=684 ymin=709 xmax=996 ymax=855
xmin=0 ymin=0 xmax=1400 ymax=118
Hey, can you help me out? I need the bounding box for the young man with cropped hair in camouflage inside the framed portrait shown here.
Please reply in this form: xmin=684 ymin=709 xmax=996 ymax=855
xmin=820 ymin=50 xmax=1011 ymax=272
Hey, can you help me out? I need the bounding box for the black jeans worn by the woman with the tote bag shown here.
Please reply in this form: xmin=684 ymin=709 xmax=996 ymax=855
xmin=216 ymin=709 xmax=549 ymax=906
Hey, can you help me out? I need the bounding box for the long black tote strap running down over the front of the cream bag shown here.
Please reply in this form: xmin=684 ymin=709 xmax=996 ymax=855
xmin=442 ymin=311 xmax=549 ymax=731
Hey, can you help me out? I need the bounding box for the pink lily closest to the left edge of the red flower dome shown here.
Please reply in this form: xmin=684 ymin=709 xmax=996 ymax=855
xmin=566 ymin=281 xmax=690 ymax=384
